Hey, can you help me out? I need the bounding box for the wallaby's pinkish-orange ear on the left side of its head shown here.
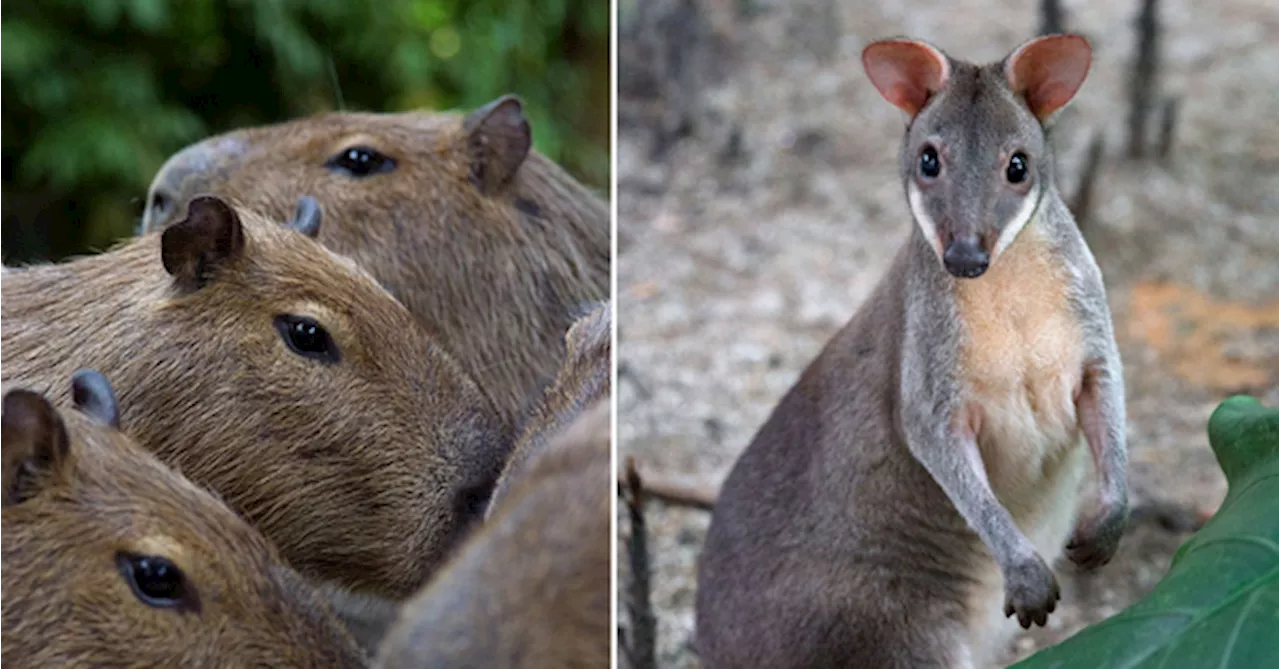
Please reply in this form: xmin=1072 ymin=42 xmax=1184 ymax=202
xmin=863 ymin=40 xmax=951 ymax=116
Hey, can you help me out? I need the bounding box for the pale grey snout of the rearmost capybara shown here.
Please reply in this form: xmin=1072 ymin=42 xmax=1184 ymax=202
xmin=138 ymin=137 xmax=244 ymax=234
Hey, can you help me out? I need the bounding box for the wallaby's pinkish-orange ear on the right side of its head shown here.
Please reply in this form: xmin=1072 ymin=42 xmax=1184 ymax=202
xmin=1005 ymin=35 xmax=1093 ymax=123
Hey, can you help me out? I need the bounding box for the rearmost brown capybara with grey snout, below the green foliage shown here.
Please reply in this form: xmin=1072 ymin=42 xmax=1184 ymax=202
xmin=142 ymin=96 xmax=611 ymax=423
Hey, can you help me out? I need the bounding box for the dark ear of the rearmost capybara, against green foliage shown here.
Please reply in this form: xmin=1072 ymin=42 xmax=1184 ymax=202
xmin=462 ymin=95 xmax=534 ymax=194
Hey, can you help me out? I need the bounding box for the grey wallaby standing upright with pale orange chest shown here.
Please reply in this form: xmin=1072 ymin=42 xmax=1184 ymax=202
xmin=696 ymin=35 xmax=1128 ymax=669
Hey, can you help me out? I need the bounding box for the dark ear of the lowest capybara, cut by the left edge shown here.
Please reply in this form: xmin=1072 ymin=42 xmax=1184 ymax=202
xmin=0 ymin=390 xmax=70 ymax=507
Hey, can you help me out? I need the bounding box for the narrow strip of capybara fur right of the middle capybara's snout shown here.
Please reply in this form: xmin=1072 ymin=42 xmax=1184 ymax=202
xmin=489 ymin=302 xmax=613 ymax=513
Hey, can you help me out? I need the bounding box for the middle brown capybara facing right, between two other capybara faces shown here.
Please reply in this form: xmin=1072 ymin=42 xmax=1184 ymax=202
xmin=0 ymin=196 xmax=511 ymax=599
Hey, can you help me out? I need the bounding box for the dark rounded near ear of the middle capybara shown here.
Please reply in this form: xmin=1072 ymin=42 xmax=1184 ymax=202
xmin=160 ymin=194 xmax=244 ymax=290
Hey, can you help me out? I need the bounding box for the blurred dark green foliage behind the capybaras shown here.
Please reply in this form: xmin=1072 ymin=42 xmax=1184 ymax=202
xmin=0 ymin=0 xmax=611 ymax=264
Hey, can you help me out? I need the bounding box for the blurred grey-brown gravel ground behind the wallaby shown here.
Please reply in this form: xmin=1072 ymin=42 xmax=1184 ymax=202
xmin=617 ymin=0 xmax=1280 ymax=668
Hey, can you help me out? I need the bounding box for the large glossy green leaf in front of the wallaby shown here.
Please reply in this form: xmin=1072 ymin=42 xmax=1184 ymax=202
xmin=1014 ymin=397 xmax=1280 ymax=669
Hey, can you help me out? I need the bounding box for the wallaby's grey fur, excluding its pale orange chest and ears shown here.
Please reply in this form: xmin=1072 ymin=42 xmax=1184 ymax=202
xmin=696 ymin=34 xmax=1128 ymax=669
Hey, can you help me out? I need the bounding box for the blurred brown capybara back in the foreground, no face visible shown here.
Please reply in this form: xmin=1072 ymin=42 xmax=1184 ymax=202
xmin=375 ymin=400 xmax=614 ymax=669
